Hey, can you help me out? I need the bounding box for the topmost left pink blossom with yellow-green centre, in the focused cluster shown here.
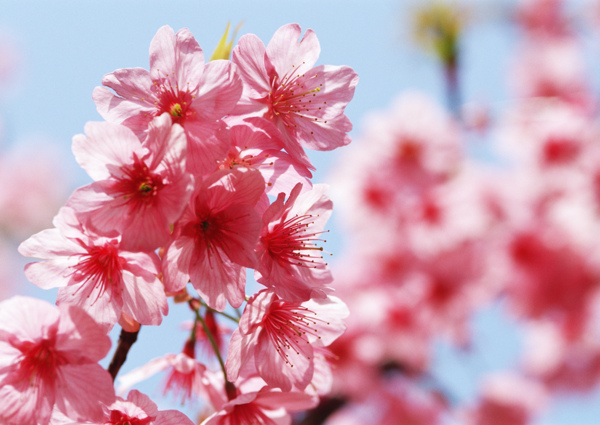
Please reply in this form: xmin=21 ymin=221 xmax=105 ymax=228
xmin=93 ymin=26 xmax=242 ymax=174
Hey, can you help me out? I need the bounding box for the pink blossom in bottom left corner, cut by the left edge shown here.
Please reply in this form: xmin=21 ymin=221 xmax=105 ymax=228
xmin=0 ymin=297 xmax=114 ymax=425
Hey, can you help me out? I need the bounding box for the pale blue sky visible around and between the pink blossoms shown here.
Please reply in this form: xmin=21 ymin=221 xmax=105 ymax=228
xmin=0 ymin=0 xmax=600 ymax=425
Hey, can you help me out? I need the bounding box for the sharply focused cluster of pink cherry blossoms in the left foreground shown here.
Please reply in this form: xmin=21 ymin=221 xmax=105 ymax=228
xmin=0 ymin=24 xmax=358 ymax=425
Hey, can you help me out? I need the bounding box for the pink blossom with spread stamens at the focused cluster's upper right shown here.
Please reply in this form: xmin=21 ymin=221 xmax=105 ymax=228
xmin=233 ymin=24 xmax=358 ymax=166
